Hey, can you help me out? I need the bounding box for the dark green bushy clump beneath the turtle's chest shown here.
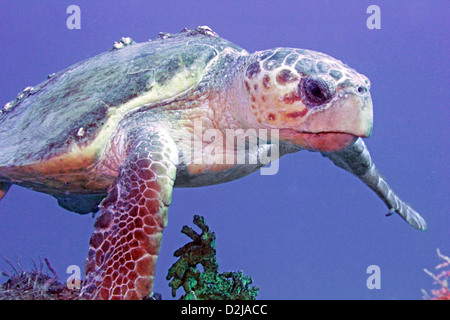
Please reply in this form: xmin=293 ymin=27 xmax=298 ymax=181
xmin=167 ymin=215 xmax=259 ymax=300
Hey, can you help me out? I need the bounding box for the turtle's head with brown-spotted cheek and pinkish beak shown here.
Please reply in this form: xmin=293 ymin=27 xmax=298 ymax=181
xmin=244 ymin=48 xmax=373 ymax=152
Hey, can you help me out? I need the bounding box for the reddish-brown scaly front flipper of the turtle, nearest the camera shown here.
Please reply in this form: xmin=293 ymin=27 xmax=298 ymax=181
xmin=82 ymin=130 xmax=177 ymax=300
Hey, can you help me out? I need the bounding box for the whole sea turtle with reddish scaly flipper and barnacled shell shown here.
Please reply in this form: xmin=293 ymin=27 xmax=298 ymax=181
xmin=0 ymin=26 xmax=426 ymax=299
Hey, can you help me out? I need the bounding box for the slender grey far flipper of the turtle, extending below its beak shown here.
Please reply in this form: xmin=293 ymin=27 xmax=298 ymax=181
xmin=323 ymin=138 xmax=427 ymax=230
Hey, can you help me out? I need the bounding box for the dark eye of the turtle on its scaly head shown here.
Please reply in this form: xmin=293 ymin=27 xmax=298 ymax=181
xmin=298 ymin=77 xmax=333 ymax=108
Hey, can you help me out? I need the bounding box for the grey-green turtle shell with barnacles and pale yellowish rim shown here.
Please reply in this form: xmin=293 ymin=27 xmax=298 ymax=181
xmin=0 ymin=27 xmax=245 ymax=170
